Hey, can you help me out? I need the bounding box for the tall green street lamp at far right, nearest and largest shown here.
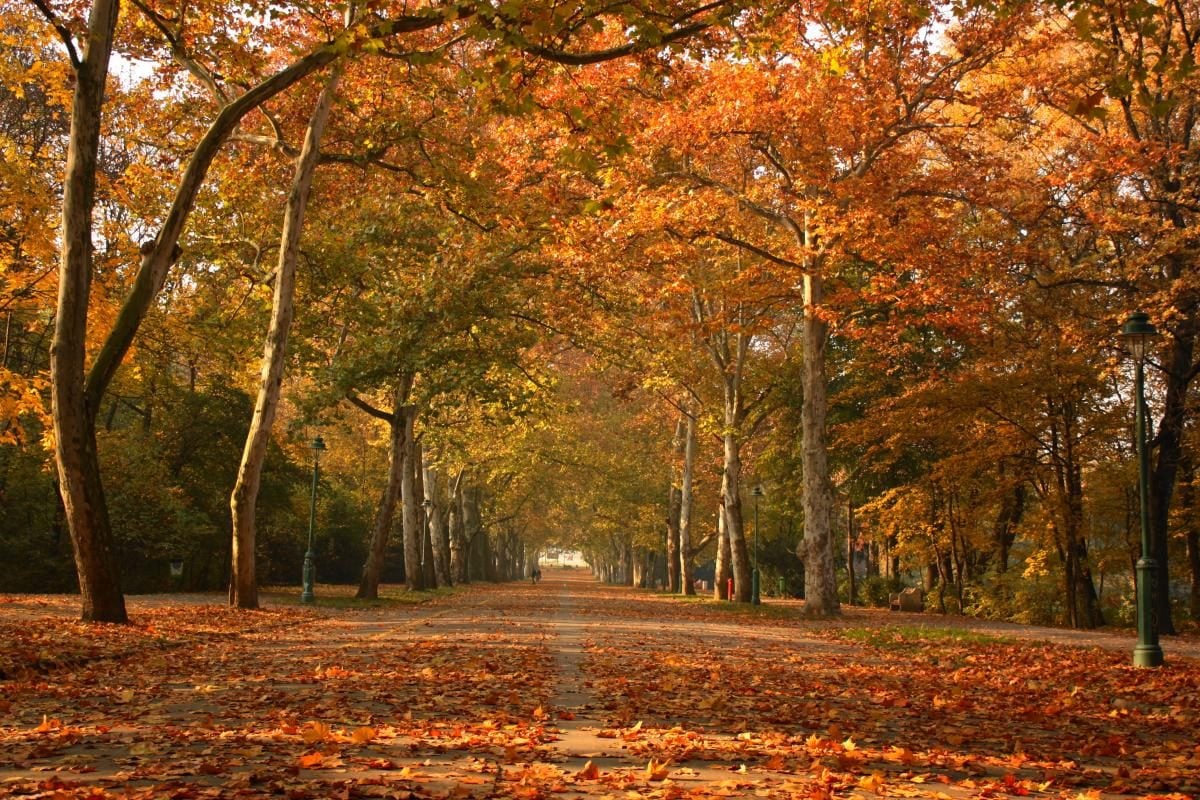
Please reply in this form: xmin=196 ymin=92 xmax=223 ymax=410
xmin=1121 ymin=311 xmax=1163 ymax=667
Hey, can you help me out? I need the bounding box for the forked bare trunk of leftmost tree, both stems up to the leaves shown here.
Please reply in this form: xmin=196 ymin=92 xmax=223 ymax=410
xmin=50 ymin=0 xmax=340 ymax=622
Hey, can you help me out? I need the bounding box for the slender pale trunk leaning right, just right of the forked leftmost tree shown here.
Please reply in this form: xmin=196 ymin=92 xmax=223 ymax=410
xmin=229 ymin=68 xmax=342 ymax=608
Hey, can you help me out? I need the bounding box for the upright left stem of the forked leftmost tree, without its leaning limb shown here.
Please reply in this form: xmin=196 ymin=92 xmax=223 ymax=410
xmin=50 ymin=0 xmax=128 ymax=622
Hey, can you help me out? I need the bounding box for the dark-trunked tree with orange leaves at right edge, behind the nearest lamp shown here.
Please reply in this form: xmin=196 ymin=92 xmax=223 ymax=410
xmin=1026 ymin=0 xmax=1200 ymax=633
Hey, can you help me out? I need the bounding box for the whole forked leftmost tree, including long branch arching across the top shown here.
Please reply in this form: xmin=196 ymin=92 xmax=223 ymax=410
xmin=38 ymin=0 xmax=739 ymax=621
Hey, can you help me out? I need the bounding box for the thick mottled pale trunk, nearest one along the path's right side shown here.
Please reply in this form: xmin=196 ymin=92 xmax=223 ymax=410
xmin=799 ymin=272 xmax=840 ymax=616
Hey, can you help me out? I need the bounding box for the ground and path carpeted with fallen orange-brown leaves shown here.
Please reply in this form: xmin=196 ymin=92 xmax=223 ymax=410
xmin=0 ymin=581 xmax=1200 ymax=800
